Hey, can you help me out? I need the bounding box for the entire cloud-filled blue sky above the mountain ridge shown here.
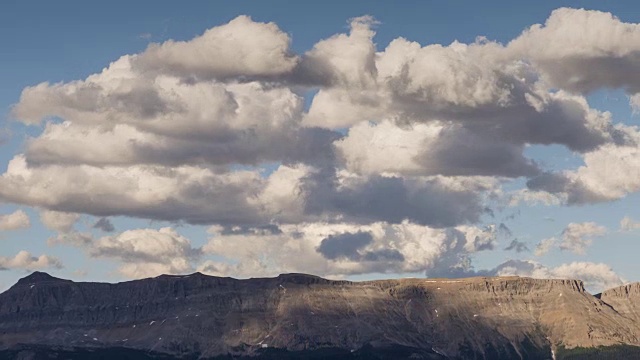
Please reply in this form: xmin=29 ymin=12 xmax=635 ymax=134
xmin=0 ymin=1 xmax=640 ymax=292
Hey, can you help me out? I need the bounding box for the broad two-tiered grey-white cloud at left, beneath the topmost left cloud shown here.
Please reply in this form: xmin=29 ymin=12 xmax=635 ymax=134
xmin=14 ymin=74 xmax=338 ymax=166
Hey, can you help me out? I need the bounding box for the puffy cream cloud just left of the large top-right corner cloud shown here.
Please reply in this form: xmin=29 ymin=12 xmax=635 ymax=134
xmin=378 ymin=38 xmax=512 ymax=109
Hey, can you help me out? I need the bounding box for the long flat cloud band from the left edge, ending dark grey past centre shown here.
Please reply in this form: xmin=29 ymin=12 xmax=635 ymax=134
xmin=0 ymin=156 xmax=495 ymax=227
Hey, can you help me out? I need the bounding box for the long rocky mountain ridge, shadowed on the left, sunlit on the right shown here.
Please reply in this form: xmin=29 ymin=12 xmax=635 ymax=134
xmin=0 ymin=272 xmax=640 ymax=359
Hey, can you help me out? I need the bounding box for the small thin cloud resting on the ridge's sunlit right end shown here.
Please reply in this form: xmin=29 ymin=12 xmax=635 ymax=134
xmin=494 ymin=260 xmax=624 ymax=294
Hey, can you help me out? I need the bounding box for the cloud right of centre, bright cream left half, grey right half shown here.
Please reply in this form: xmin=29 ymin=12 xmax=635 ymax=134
xmin=334 ymin=121 xmax=539 ymax=177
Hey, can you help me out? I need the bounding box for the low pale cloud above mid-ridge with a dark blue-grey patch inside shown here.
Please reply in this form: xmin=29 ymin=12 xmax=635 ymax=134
xmin=199 ymin=222 xmax=495 ymax=277
